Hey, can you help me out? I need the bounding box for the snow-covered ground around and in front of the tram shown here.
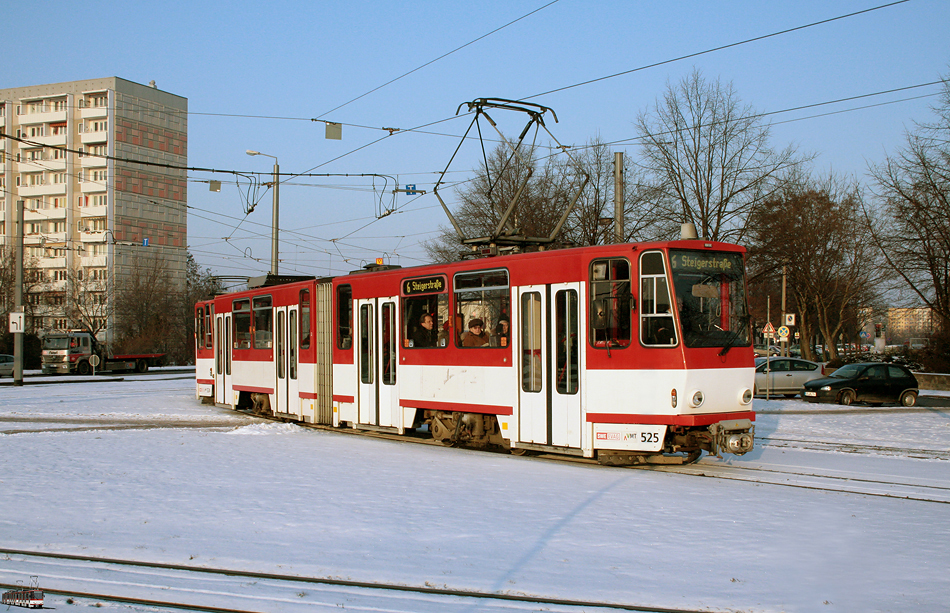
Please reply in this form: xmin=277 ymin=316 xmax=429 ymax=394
xmin=0 ymin=373 xmax=950 ymax=612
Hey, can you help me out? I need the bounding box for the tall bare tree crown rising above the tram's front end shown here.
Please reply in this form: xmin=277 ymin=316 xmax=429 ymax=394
xmin=637 ymin=69 xmax=803 ymax=242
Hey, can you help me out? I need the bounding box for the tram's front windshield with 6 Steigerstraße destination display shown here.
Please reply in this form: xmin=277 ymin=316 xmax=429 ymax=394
xmin=670 ymin=249 xmax=750 ymax=352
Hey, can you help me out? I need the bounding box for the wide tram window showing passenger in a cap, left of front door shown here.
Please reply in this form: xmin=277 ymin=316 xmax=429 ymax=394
xmin=454 ymin=269 xmax=511 ymax=347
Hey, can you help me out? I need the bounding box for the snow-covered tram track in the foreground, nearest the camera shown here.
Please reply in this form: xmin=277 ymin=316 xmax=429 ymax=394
xmin=0 ymin=549 xmax=715 ymax=613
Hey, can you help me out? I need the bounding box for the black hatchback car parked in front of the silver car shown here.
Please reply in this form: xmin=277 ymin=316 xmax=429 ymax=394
xmin=802 ymin=362 xmax=918 ymax=407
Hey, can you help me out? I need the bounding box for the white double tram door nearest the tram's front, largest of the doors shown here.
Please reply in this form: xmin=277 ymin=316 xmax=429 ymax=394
xmin=516 ymin=283 xmax=583 ymax=448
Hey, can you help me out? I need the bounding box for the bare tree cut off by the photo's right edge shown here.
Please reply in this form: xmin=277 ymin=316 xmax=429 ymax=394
xmin=869 ymin=80 xmax=950 ymax=334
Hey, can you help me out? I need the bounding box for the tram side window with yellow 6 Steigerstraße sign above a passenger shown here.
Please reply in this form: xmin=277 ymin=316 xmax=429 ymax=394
xmin=401 ymin=275 xmax=451 ymax=349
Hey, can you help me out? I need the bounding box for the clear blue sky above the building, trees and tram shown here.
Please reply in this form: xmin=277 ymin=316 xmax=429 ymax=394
xmin=0 ymin=0 xmax=950 ymax=275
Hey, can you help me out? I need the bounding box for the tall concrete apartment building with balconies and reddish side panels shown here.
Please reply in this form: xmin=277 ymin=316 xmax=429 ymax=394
xmin=0 ymin=77 xmax=188 ymax=341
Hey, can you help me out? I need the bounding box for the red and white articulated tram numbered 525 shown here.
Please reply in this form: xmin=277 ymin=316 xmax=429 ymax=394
xmin=196 ymin=240 xmax=755 ymax=465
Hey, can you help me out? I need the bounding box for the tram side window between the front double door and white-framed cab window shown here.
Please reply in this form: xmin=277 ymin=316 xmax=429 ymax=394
xmin=590 ymin=258 xmax=632 ymax=348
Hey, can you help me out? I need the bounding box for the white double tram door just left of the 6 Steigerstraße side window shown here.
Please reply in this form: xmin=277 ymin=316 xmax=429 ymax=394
xmin=356 ymin=298 xmax=400 ymax=427
